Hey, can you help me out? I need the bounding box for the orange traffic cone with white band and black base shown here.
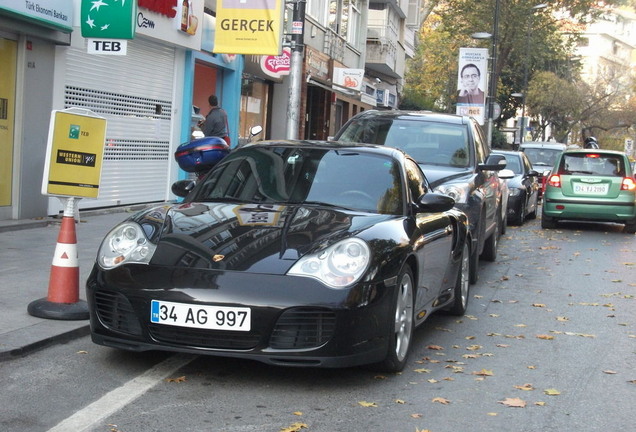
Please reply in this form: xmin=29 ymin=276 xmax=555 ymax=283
xmin=27 ymin=198 xmax=88 ymax=320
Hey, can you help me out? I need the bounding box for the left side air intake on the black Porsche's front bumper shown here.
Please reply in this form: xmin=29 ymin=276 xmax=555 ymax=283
xmin=95 ymin=291 xmax=141 ymax=336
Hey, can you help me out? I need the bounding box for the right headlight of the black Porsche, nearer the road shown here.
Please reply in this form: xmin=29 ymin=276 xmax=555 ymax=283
xmin=288 ymin=238 xmax=371 ymax=288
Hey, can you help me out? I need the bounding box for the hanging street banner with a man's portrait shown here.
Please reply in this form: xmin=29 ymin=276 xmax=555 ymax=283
xmin=456 ymin=48 xmax=488 ymax=125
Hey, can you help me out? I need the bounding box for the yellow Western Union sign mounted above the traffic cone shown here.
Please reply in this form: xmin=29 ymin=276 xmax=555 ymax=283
xmin=42 ymin=108 xmax=106 ymax=198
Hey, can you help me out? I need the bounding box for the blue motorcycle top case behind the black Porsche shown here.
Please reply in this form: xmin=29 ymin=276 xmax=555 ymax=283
xmin=174 ymin=137 xmax=230 ymax=173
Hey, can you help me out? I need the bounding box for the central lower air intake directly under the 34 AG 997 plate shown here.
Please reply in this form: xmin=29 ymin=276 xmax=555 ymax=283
xmin=148 ymin=324 xmax=260 ymax=350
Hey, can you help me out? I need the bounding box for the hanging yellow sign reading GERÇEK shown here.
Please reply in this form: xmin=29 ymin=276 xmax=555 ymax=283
xmin=214 ymin=0 xmax=285 ymax=55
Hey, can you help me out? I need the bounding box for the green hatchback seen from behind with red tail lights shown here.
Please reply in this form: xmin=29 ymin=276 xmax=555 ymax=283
xmin=541 ymin=149 xmax=636 ymax=234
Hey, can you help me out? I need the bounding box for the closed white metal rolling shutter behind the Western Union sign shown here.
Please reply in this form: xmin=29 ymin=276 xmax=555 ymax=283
xmin=59 ymin=39 xmax=175 ymax=208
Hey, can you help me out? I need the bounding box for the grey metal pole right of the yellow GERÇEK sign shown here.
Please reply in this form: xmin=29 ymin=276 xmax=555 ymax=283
xmin=285 ymin=0 xmax=306 ymax=139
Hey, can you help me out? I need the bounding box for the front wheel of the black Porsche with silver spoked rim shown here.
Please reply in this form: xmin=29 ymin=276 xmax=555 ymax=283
xmin=380 ymin=266 xmax=415 ymax=372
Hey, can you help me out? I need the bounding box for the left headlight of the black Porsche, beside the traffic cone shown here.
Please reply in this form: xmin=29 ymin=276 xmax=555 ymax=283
xmin=97 ymin=222 xmax=157 ymax=269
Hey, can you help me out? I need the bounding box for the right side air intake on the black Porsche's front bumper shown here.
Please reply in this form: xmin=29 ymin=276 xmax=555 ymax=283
xmin=269 ymin=308 xmax=336 ymax=349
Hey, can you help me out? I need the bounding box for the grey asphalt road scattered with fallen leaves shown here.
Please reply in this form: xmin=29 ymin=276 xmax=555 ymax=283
xmin=0 ymin=216 xmax=636 ymax=432
